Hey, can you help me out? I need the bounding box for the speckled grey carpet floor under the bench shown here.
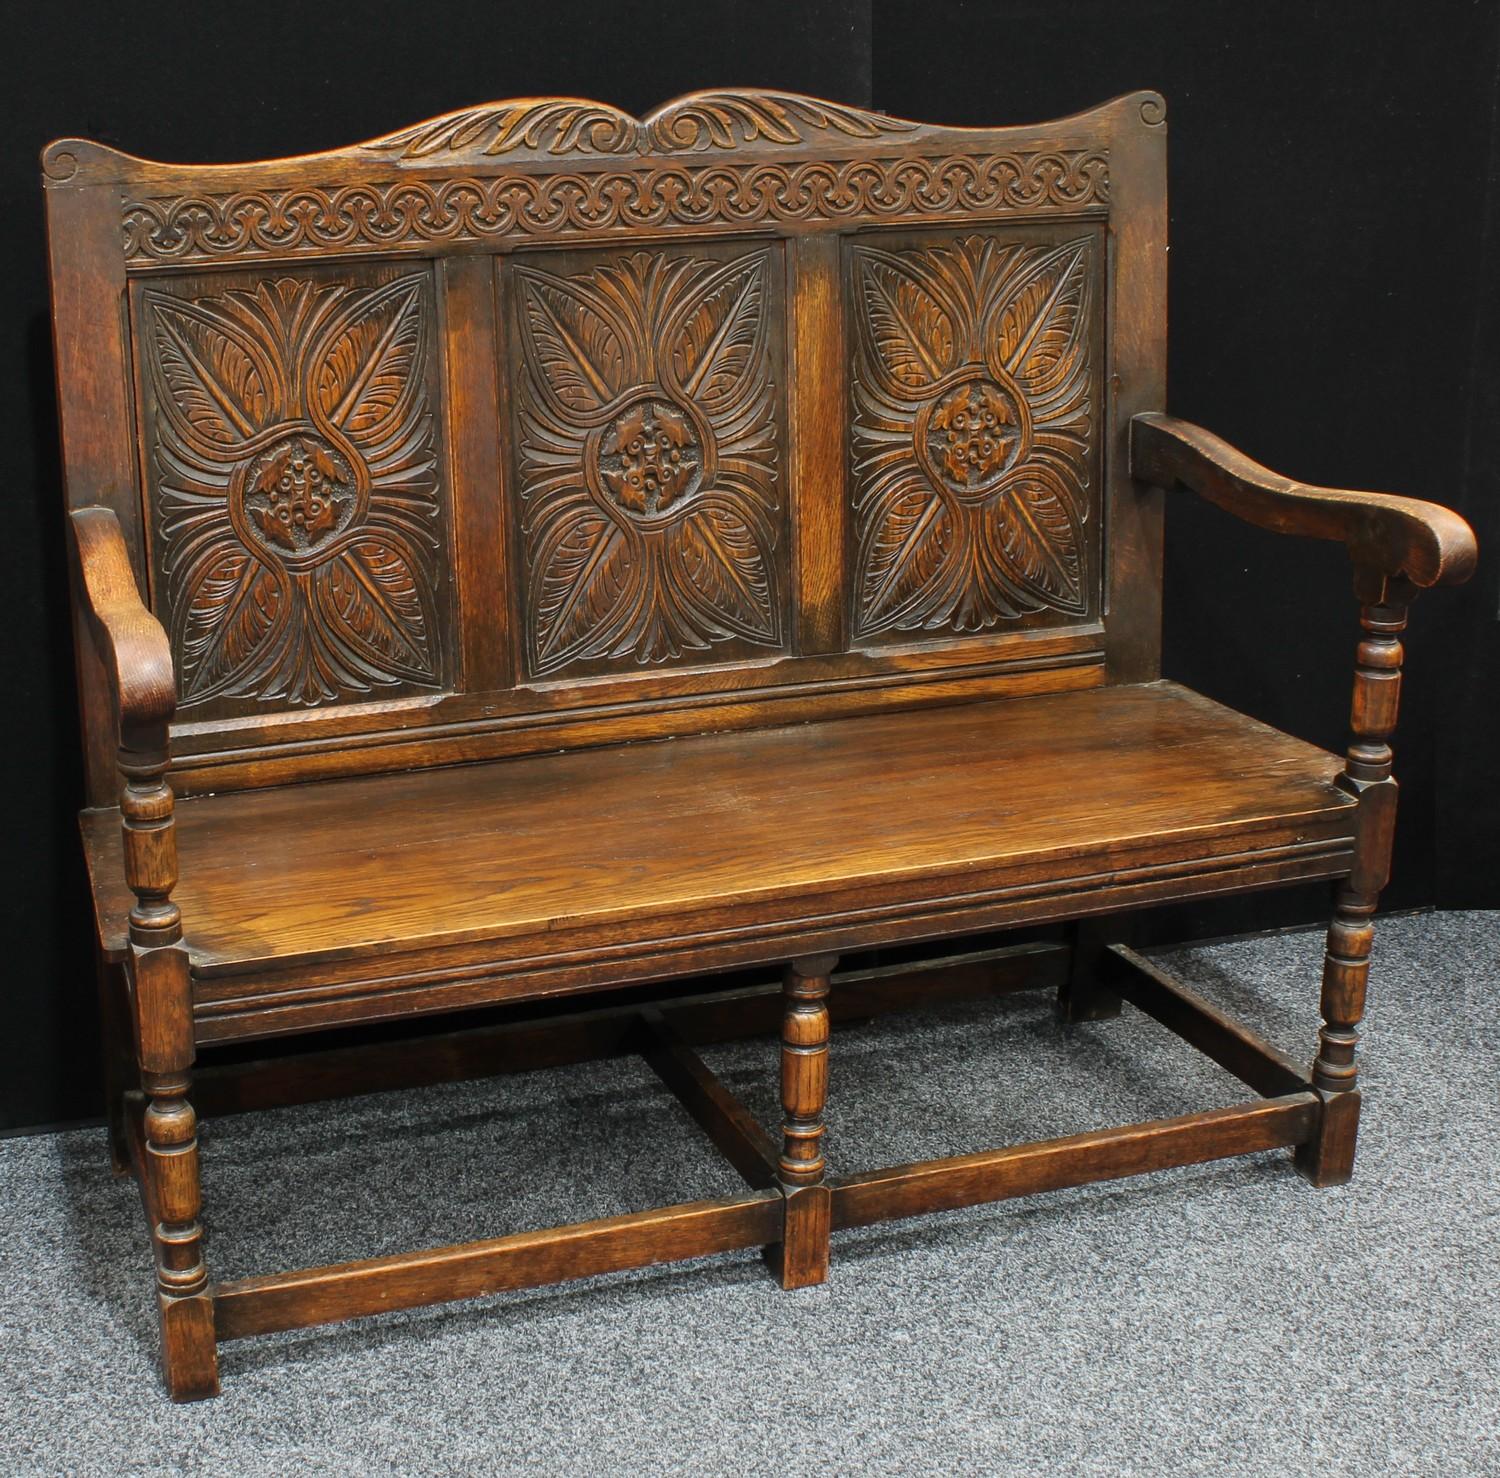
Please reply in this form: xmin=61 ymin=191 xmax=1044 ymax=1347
xmin=0 ymin=914 xmax=1500 ymax=1478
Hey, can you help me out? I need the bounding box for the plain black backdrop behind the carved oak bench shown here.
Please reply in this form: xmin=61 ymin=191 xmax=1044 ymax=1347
xmin=0 ymin=0 xmax=1500 ymax=1128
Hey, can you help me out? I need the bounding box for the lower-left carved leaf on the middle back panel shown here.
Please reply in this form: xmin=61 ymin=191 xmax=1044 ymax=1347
xmin=533 ymin=507 xmax=641 ymax=671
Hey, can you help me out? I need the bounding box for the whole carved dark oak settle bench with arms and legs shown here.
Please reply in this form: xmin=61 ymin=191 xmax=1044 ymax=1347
xmin=44 ymin=92 xmax=1475 ymax=1398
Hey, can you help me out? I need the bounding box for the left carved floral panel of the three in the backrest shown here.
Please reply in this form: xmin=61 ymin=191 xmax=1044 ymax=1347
xmin=132 ymin=269 xmax=452 ymax=719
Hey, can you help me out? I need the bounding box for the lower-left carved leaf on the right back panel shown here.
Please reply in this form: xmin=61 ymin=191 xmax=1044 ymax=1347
xmin=858 ymin=479 xmax=954 ymax=635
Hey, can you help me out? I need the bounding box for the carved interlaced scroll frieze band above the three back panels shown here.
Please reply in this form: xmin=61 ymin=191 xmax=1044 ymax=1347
xmin=123 ymin=149 xmax=1109 ymax=267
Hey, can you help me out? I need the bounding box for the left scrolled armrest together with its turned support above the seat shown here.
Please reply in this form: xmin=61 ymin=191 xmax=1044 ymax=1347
xmin=71 ymin=507 xmax=182 ymax=950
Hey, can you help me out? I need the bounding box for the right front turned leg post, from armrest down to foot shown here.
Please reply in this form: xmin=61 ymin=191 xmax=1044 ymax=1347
xmin=1296 ymin=578 xmax=1410 ymax=1185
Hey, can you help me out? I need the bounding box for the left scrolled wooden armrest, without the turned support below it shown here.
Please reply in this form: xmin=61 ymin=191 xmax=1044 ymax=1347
xmin=69 ymin=507 xmax=177 ymax=747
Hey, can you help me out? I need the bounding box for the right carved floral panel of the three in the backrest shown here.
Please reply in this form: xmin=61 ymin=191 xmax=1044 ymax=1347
xmin=848 ymin=234 xmax=1100 ymax=645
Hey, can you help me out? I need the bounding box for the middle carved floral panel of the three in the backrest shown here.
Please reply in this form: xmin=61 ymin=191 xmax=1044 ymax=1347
xmin=513 ymin=248 xmax=785 ymax=675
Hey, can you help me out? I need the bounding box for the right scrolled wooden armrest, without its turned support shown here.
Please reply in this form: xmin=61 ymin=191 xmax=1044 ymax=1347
xmin=1131 ymin=411 xmax=1478 ymax=587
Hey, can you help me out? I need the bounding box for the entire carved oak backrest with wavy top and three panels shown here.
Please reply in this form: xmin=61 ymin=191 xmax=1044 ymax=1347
xmin=44 ymin=93 xmax=1166 ymax=800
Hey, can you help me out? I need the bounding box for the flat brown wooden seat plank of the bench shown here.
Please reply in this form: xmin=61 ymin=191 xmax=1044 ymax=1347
xmin=84 ymin=683 xmax=1353 ymax=975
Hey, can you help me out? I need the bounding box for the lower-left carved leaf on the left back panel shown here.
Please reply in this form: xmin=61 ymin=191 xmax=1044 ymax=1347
xmin=174 ymin=543 xmax=287 ymax=701
